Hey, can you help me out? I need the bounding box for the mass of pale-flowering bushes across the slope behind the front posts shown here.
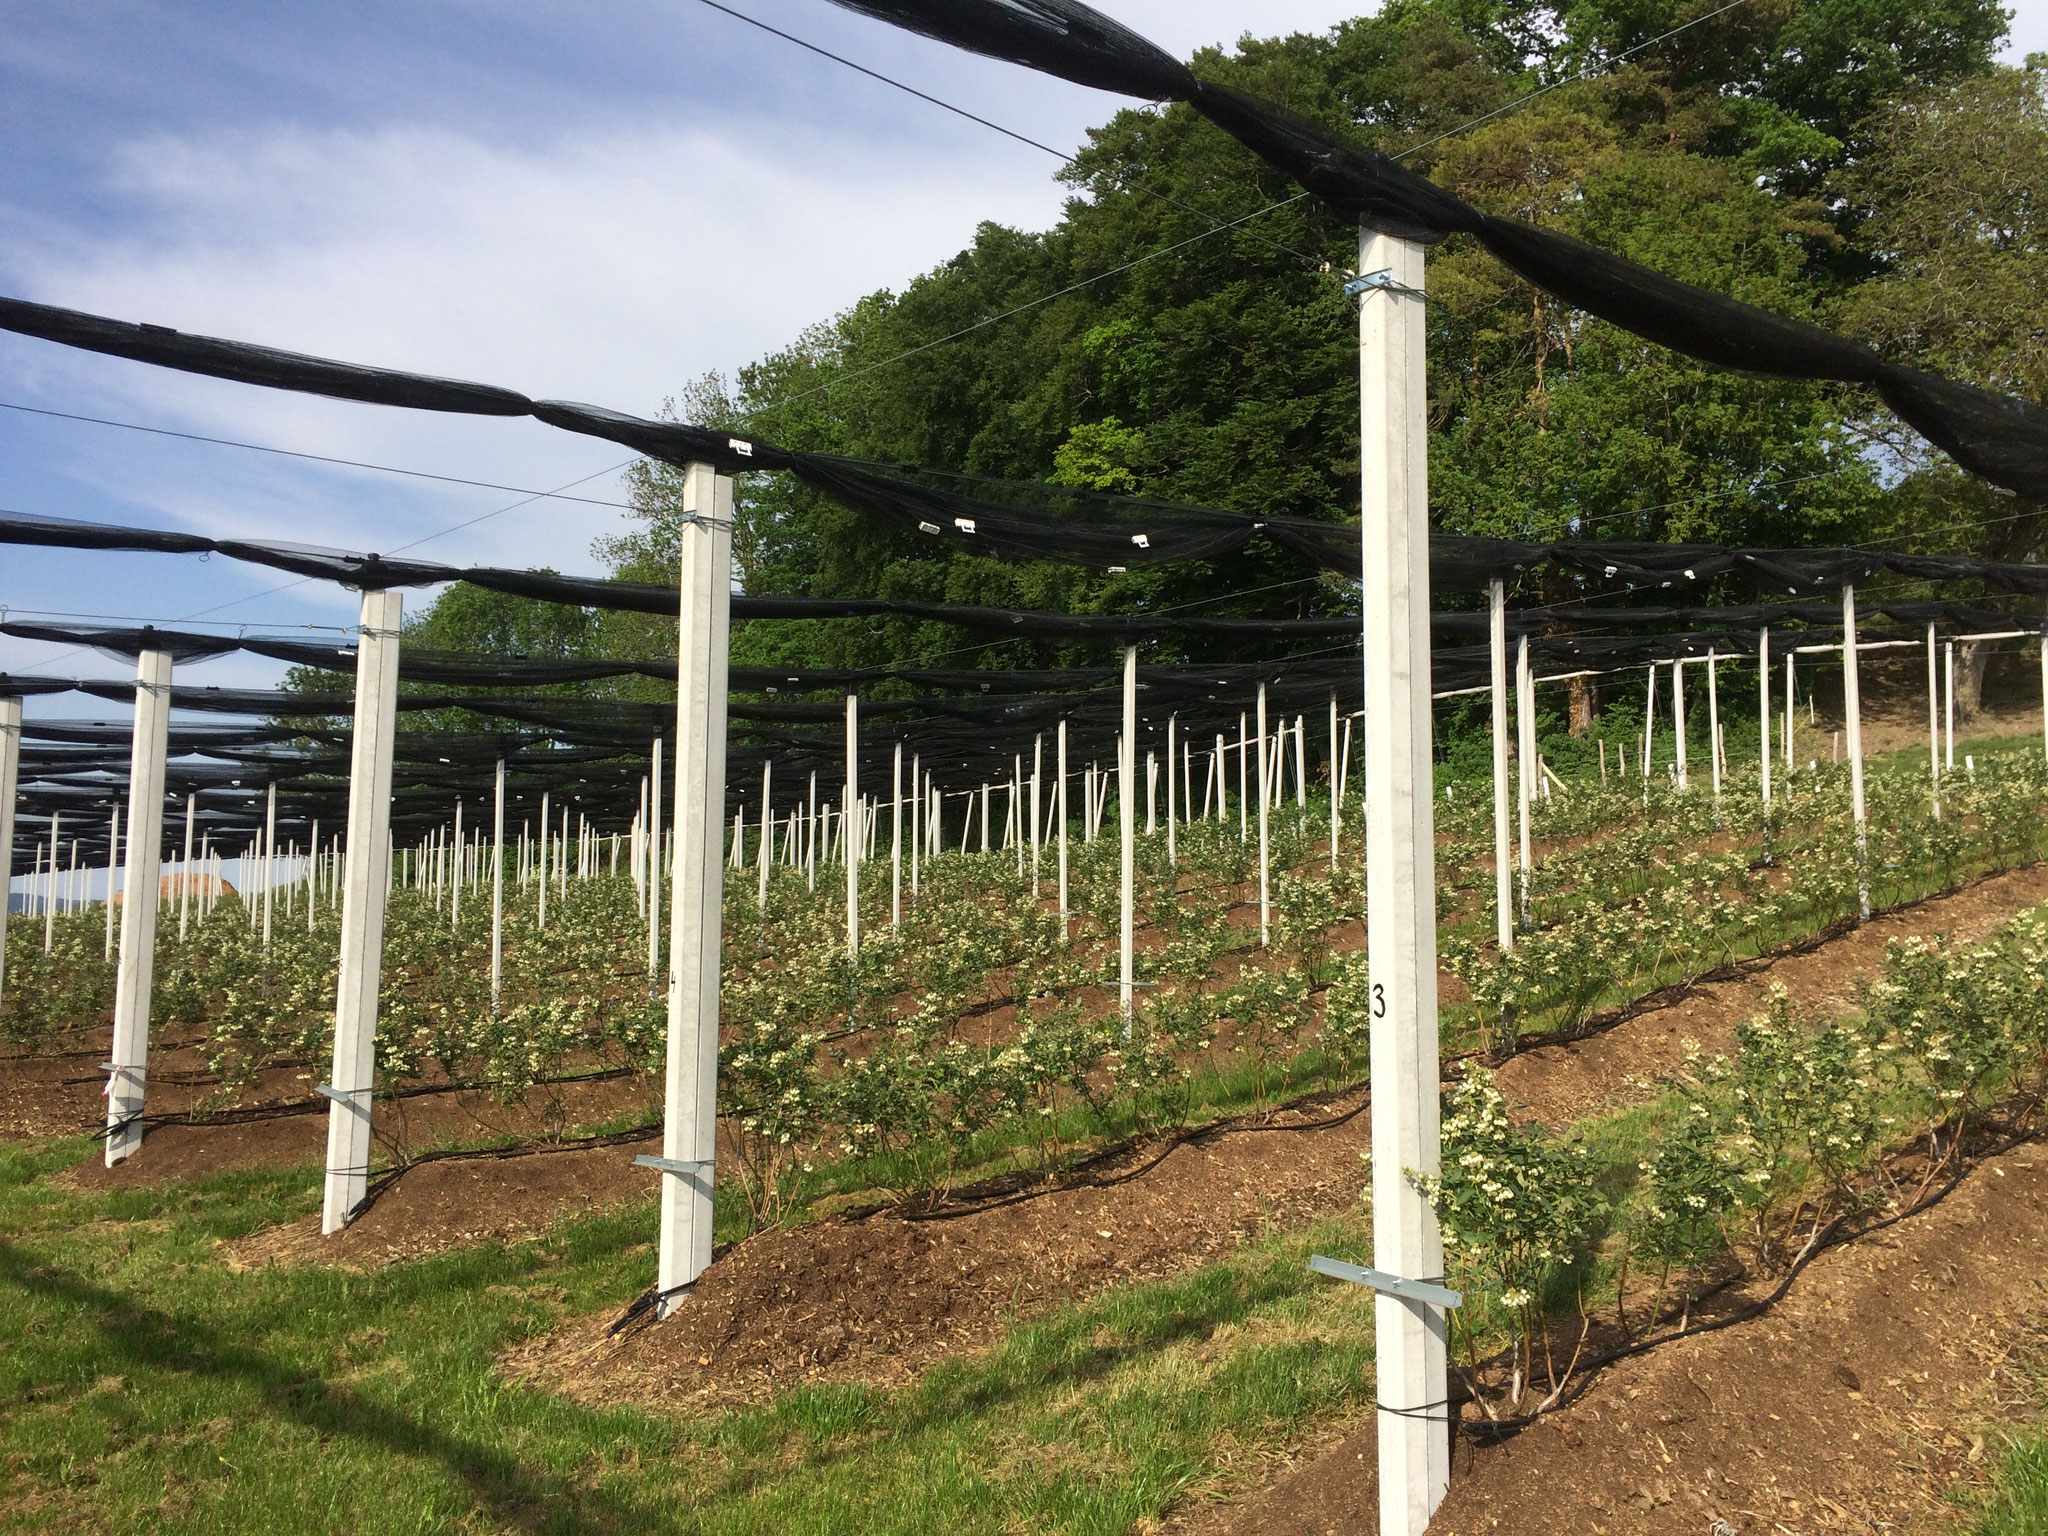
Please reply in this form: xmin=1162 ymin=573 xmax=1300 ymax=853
xmin=16 ymin=720 xmax=2048 ymax=1223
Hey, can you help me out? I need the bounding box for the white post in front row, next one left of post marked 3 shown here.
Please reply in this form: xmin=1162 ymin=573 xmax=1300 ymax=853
xmin=655 ymin=463 xmax=729 ymax=1317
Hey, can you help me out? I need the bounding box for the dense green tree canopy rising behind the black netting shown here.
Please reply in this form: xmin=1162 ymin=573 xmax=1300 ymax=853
xmin=407 ymin=0 xmax=2023 ymax=679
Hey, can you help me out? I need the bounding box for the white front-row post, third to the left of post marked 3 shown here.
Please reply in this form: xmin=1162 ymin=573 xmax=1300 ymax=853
xmin=106 ymin=651 xmax=170 ymax=1167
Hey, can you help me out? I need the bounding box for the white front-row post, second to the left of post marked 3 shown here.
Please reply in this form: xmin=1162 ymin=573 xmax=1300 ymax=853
xmin=319 ymin=590 xmax=406 ymax=1233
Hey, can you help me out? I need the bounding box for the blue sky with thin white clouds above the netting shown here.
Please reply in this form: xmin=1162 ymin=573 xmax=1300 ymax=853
xmin=0 ymin=0 xmax=2048 ymax=715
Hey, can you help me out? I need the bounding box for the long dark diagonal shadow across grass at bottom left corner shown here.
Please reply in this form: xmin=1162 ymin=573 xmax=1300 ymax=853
xmin=0 ymin=1239 xmax=668 ymax=1536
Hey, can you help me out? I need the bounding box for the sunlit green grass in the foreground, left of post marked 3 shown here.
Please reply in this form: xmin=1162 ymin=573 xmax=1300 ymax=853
xmin=0 ymin=1139 xmax=1372 ymax=1536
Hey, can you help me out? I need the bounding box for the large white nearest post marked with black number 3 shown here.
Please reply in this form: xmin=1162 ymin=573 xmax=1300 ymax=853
xmin=1358 ymin=222 xmax=1450 ymax=1536
